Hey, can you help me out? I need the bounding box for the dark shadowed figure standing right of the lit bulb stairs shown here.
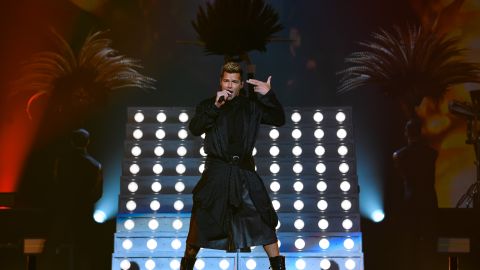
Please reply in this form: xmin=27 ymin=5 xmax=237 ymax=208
xmin=393 ymin=119 xmax=438 ymax=269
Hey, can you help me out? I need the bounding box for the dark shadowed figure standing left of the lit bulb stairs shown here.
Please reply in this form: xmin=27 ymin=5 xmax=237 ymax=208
xmin=44 ymin=129 xmax=103 ymax=270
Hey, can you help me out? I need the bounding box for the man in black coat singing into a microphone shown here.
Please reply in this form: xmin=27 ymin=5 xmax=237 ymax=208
xmin=180 ymin=62 xmax=285 ymax=270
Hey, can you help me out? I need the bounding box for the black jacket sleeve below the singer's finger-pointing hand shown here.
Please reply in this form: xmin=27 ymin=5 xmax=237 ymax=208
xmin=257 ymin=90 xmax=285 ymax=127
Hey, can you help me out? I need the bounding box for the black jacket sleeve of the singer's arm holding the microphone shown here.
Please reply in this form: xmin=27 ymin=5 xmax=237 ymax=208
xmin=188 ymin=99 xmax=220 ymax=136
